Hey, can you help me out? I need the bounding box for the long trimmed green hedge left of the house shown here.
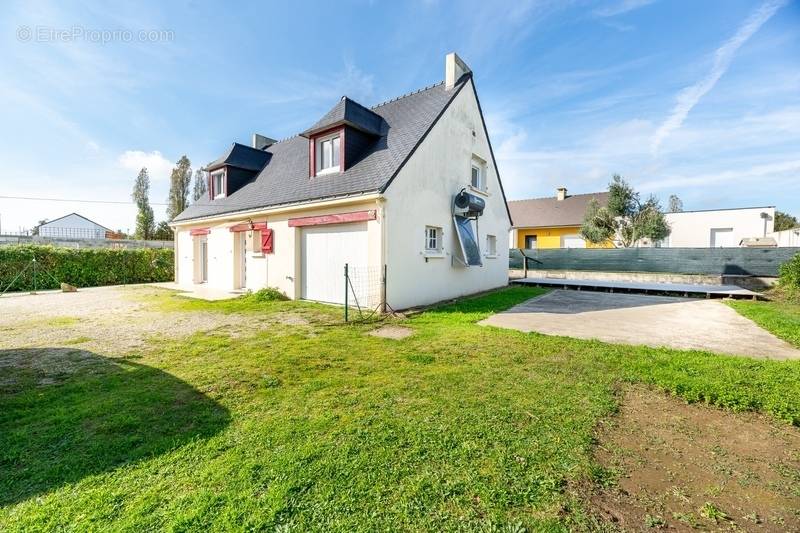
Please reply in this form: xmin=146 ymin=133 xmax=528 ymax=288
xmin=0 ymin=245 xmax=174 ymax=292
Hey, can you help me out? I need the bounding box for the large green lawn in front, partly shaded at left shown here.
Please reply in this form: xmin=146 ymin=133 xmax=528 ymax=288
xmin=0 ymin=287 xmax=800 ymax=531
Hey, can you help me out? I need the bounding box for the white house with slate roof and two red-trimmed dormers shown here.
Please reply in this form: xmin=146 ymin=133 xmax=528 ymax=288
xmin=172 ymin=54 xmax=511 ymax=309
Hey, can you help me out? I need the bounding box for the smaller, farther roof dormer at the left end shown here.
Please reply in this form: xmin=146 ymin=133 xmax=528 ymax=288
xmin=206 ymin=143 xmax=272 ymax=200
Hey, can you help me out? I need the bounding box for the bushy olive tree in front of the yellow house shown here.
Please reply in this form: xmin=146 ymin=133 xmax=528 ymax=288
xmin=581 ymin=174 xmax=670 ymax=248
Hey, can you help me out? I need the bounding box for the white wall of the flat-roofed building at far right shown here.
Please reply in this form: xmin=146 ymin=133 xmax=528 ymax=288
xmin=665 ymin=207 xmax=775 ymax=248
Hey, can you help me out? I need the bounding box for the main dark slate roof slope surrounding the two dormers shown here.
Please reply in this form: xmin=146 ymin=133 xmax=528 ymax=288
xmin=175 ymin=76 xmax=469 ymax=222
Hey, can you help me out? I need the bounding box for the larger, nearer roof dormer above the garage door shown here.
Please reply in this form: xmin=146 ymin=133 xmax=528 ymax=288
xmin=301 ymin=96 xmax=384 ymax=177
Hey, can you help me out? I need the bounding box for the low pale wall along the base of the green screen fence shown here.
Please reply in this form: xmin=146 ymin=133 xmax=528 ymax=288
xmin=508 ymin=269 xmax=777 ymax=290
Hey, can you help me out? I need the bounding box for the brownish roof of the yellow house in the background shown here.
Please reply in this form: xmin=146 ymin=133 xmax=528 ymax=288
xmin=508 ymin=192 xmax=608 ymax=228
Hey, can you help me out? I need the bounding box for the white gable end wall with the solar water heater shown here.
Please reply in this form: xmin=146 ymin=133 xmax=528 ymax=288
xmin=384 ymin=80 xmax=511 ymax=309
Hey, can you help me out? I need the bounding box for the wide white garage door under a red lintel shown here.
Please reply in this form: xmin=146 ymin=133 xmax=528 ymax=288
xmin=302 ymin=222 xmax=367 ymax=304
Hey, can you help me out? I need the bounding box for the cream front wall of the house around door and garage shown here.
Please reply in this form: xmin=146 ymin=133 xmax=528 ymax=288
xmin=175 ymin=201 xmax=382 ymax=299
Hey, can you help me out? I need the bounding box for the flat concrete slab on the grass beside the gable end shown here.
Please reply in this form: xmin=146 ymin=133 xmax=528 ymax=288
xmin=480 ymin=290 xmax=800 ymax=359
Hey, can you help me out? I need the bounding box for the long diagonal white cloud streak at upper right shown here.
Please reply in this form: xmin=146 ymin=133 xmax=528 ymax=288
xmin=651 ymin=0 xmax=786 ymax=155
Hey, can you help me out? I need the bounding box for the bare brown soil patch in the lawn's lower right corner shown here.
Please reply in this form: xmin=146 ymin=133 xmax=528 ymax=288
xmin=590 ymin=387 xmax=800 ymax=531
